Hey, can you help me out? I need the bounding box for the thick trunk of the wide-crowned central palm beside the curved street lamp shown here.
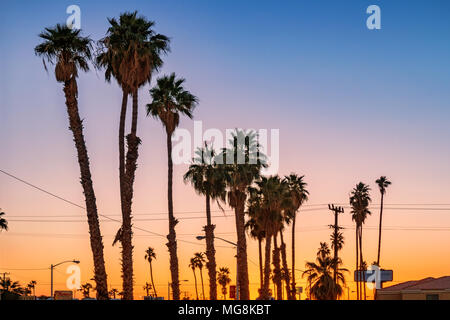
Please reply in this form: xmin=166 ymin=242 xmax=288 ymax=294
xmin=235 ymin=191 xmax=250 ymax=300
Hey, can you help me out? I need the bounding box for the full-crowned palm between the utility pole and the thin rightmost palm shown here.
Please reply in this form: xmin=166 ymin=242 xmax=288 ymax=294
xmin=350 ymin=182 xmax=372 ymax=299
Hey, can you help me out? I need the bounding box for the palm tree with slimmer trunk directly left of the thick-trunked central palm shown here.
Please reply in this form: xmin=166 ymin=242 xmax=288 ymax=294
xmin=184 ymin=143 xmax=226 ymax=300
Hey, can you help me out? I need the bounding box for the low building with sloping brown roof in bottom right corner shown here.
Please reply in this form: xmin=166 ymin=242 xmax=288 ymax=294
xmin=375 ymin=276 xmax=450 ymax=300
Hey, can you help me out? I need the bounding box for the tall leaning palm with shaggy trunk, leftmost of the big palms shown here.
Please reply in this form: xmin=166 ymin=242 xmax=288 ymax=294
xmin=34 ymin=24 xmax=108 ymax=300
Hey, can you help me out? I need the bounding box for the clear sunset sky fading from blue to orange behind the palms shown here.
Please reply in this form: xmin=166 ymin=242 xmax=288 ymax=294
xmin=0 ymin=0 xmax=450 ymax=298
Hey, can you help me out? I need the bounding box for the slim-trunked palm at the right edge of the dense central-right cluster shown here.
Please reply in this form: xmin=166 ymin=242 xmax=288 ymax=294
xmin=284 ymin=173 xmax=309 ymax=299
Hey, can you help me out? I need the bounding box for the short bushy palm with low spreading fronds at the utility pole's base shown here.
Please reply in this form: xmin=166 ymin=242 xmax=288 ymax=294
xmin=302 ymin=242 xmax=348 ymax=300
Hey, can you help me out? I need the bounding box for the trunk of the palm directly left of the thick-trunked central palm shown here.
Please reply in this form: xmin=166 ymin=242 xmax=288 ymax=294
xmin=205 ymin=194 xmax=217 ymax=300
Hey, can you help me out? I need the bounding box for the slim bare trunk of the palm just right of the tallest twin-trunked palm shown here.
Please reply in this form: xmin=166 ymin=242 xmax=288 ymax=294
xmin=166 ymin=131 xmax=180 ymax=300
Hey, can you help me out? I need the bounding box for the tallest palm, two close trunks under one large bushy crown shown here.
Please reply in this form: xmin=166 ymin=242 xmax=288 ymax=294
xmin=96 ymin=11 xmax=169 ymax=300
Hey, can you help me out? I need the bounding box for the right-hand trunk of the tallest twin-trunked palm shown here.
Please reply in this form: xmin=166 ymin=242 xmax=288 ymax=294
xmin=121 ymin=89 xmax=140 ymax=300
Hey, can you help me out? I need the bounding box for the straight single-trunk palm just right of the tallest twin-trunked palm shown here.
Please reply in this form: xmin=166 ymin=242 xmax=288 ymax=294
xmin=147 ymin=73 xmax=198 ymax=300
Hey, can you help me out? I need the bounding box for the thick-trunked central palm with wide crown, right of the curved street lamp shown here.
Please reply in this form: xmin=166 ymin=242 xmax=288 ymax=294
xmin=216 ymin=129 xmax=267 ymax=300
